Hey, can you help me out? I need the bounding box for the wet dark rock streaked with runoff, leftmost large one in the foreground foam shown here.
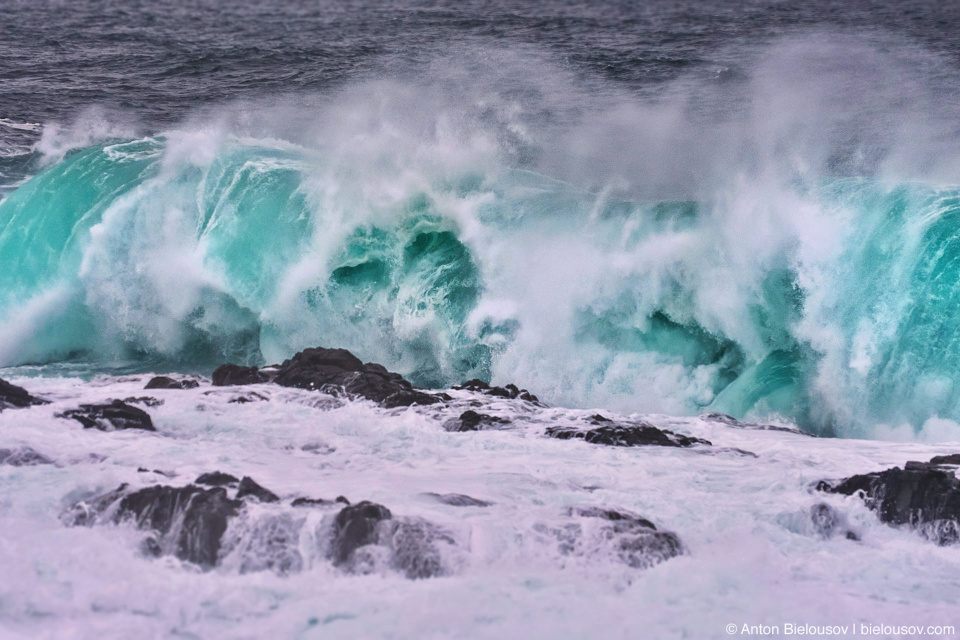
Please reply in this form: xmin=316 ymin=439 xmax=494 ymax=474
xmin=115 ymin=485 xmax=242 ymax=568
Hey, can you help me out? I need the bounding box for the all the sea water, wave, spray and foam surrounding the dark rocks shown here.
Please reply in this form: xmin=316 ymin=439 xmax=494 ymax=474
xmin=0 ymin=0 xmax=960 ymax=638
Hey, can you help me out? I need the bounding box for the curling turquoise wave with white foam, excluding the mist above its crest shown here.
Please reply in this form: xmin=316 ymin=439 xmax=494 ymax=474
xmin=0 ymin=137 xmax=960 ymax=435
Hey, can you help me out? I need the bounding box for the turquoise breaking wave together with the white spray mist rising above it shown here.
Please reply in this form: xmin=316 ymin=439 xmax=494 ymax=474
xmin=0 ymin=42 xmax=960 ymax=435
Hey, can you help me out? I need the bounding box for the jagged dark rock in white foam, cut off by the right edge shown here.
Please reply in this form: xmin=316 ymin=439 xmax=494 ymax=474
xmin=816 ymin=462 xmax=960 ymax=545
